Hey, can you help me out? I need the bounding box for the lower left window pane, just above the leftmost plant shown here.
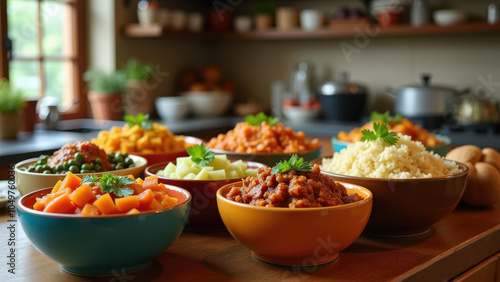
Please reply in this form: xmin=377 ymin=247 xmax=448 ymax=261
xmin=9 ymin=61 xmax=40 ymax=98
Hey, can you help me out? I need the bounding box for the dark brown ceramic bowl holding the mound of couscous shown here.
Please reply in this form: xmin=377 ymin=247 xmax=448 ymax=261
xmin=311 ymin=157 xmax=469 ymax=236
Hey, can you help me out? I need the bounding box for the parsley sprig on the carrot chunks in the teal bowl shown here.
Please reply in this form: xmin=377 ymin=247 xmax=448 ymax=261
xmin=82 ymin=173 xmax=135 ymax=197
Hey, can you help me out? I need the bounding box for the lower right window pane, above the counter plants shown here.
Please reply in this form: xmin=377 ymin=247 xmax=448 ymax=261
xmin=43 ymin=61 xmax=74 ymax=108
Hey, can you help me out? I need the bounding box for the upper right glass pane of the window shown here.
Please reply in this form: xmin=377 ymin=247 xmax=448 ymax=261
xmin=41 ymin=2 xmax=71 ymax=56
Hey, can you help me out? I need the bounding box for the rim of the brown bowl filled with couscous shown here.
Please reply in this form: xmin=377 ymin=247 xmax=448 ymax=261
xmin=311 ymin=156 xmax=469 ymax=182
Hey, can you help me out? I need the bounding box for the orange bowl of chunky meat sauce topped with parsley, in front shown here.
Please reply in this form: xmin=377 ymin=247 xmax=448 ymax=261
xmin=217 ymin=156 xmax=373 ymax=266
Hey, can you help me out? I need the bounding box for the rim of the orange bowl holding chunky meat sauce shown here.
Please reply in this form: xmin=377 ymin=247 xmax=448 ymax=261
xmin=216 ymin=181 xmax=373 ymax=213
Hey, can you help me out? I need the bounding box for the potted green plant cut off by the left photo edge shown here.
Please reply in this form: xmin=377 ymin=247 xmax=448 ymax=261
xmin=0 ymin=79 xmax=26 ymax=139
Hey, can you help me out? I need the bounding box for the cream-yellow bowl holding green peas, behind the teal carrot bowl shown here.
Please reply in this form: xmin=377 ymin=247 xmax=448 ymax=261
xmin=14 ymin=155 xmax=148 ymax=195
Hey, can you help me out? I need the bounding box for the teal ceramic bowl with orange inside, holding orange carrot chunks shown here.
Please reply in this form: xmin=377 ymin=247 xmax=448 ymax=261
xmin=17 ymin=185 xmax=191 ymax=276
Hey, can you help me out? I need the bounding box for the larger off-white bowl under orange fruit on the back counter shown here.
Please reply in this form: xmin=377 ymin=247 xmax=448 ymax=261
xmin=181 ymin=92 xmax=233 ymax=117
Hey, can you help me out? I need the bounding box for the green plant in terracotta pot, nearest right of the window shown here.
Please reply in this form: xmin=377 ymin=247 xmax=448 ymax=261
xmin=83 ymin=70 xmax=127 ymax=120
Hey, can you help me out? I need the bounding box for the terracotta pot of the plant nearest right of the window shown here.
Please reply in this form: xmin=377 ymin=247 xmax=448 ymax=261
xmin=88 ymin=91 xmax=123 ymax=120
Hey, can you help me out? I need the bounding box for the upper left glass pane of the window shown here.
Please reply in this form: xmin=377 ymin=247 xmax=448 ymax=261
xmin=7 ymin=0 xmax=38 ymax=57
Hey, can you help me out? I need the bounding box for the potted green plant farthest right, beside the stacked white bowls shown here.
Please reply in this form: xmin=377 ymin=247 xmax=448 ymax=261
xmin=123 ymin=59 xmax=154 ymax=115
